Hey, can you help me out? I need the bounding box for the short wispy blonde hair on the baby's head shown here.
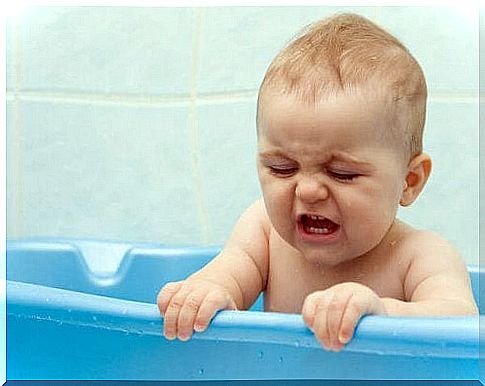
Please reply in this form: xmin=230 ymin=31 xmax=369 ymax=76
xmin=258 ymin=14 xmax=427 ymax=157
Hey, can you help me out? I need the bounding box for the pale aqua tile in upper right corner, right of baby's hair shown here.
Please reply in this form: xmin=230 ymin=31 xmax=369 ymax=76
xmin=377 ymin=7 xmax=479 ymax=92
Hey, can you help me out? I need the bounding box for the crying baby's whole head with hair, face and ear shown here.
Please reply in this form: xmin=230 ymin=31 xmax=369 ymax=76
xmin=257 ymin=14 xmax=431 ymax=264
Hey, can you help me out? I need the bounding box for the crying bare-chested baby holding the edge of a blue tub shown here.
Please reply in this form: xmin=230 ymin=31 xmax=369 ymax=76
xmin=157 ymin=14 xmax=477 ymax=351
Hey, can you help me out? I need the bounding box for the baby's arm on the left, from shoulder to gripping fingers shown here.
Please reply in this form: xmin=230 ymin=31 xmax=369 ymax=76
xmin=157 ymin=199 xmax=269 ymax=340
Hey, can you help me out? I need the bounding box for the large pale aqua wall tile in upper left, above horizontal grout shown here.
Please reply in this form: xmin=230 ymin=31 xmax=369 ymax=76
xmin=21 ymin=7 xmax=193 ymax=94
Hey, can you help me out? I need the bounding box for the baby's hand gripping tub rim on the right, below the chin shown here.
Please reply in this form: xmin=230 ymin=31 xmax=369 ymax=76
xmin=302 ymin=283 xmax=386 ymax=351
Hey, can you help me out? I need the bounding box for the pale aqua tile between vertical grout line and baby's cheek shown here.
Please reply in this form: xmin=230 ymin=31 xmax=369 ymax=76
xmin=198 ymin=99 xmax=261 ymax=244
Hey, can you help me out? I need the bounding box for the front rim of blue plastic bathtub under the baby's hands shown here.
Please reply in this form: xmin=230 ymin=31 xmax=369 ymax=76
xmin=6 ymin=280 xmax=478 ymax=365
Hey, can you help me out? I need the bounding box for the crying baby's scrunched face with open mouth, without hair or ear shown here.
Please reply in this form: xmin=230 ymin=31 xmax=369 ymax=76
xmin=258 ymin=91 xmax=407 ymax=266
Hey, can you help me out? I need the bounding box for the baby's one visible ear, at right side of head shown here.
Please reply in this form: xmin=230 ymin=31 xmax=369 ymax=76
xmin=400 ymin=153 xmax=431 ymax=206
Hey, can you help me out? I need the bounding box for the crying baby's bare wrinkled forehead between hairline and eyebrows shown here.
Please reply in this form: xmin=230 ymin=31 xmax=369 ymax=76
xmin=257 ymin=85 xmax=406 ymax=155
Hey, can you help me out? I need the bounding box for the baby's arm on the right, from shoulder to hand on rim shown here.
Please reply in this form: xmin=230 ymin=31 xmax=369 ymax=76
xmin=302 ymin=232 xmax=477 ymax=351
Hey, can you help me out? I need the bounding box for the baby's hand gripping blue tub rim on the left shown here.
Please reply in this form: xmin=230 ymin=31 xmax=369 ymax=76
xmin=157 ymin=279 xmax=236 ymax=340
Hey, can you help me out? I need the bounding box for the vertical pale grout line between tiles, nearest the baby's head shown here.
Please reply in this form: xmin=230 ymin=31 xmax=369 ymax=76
xmin=190 ymin=8 xmax=210 ymax=244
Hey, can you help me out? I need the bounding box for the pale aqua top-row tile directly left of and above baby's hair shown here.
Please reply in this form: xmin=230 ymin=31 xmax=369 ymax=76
xmin=197 ymin=6 xmax=376 ymax=93
